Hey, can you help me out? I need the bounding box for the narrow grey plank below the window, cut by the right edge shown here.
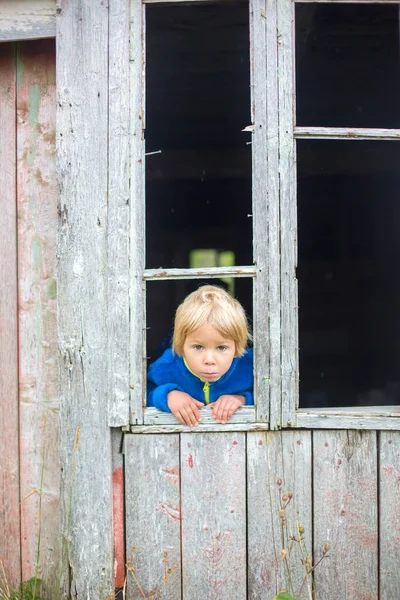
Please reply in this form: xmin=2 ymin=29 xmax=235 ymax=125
xmin=379 ymin=431 xmax=400 ymax=600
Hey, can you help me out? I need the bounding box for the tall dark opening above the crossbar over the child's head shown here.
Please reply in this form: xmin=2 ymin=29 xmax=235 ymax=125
xmin=145 ymin=2 xmax=252 ymax=268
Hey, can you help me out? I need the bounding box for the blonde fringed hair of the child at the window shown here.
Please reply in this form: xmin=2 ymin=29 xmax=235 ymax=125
xmin=172 ymin=285 xmax=251 ymax=356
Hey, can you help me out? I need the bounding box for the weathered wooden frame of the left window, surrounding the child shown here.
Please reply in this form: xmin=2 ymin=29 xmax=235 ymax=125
xmin=130 ymin=0 xmax=280 ymax=433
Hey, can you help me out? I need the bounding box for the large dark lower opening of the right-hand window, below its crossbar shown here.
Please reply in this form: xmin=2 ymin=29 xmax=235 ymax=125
xmin=297 ymin=140 xmax=400 ymax=407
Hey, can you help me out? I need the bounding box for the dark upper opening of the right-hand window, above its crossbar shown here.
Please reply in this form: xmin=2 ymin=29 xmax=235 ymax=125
xmin=296 ymin=3 xmax=400 ymax=128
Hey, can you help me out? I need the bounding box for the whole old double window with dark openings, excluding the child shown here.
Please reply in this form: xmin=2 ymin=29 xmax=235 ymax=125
xmin=130 ymin=0 xmax=400 ymax=429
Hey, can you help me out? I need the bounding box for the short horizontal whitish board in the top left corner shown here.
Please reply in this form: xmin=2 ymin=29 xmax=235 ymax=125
xmin=0 ymin=0 xmax=56 ymax=42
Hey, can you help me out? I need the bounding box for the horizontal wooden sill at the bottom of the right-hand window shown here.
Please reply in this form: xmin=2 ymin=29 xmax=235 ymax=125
xmin=297 ymin=406 xmax=400 ymax=430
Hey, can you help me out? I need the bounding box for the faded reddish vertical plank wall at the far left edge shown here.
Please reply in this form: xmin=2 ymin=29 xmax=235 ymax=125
xmin=0 ymin=40 xmax=60 ymax=586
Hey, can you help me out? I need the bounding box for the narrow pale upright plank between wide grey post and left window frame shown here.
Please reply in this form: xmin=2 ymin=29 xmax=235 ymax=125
xmin=107 ymin=0 xmax=130 ymax=427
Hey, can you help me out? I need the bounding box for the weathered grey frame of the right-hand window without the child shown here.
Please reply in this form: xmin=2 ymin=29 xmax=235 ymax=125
xmin=278 ymin=0 xmax=400 ymax=430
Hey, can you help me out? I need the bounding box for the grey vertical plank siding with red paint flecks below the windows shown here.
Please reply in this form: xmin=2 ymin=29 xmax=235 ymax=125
xmin=125 ymin=431 xmax=400 ymax=600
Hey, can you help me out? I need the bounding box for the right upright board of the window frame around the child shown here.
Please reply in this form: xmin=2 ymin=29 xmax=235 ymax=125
xmin=250 ymin=0 xmax=280 ymax=421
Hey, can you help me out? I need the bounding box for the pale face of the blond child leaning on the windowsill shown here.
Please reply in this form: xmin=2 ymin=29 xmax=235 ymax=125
xmin=183 ymin=323 xmax=236 ymax=381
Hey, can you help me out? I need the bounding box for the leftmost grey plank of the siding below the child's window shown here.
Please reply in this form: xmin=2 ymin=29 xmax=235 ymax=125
xmin=125 ymin=435 xmax=181 ymax=600
